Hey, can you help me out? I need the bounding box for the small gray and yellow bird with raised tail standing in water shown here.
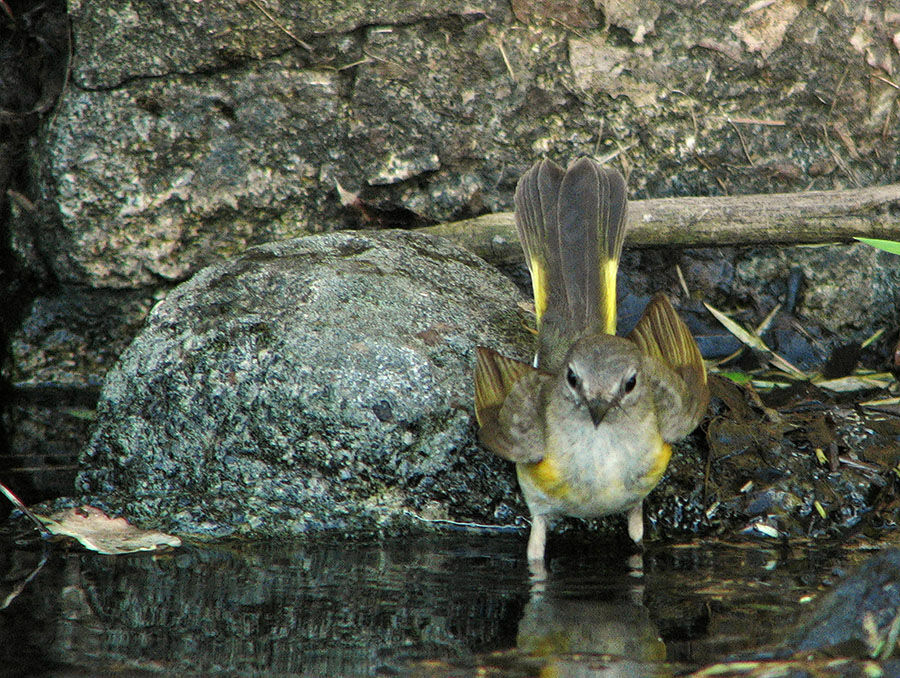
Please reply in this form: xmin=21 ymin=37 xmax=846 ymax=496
xmin=475 ymin=157 xmax=709 ymax=562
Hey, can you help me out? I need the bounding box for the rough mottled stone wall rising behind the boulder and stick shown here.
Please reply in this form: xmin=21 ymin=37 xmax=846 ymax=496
xmin=4 ymin=0 xmax=900 ymax=504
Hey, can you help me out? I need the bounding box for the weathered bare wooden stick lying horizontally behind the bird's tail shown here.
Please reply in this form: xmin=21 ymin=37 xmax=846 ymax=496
xmin=417 ymin=184 xmax=900 ymax=264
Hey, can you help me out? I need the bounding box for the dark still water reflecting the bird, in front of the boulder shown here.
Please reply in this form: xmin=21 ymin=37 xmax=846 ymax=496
xmin=0 ymin=532 xmax=860 ymax=676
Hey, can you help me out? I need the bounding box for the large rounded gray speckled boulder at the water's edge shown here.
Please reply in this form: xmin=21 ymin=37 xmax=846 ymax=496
xmin=78 ymin=231 xmax=529 ymax=536
